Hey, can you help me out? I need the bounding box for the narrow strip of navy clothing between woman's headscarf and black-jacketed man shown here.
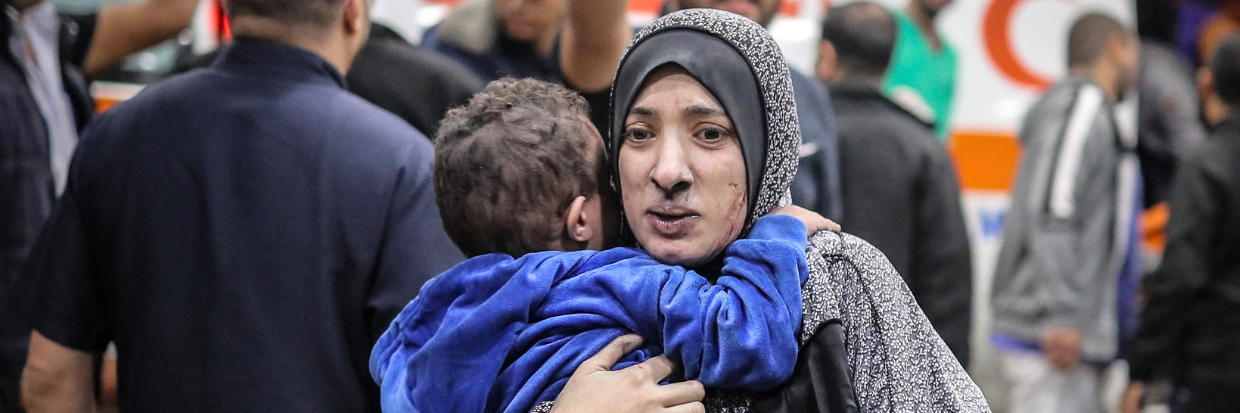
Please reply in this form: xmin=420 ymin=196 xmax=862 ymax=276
xmin=789 ymin=67 xmax=843 ymax=221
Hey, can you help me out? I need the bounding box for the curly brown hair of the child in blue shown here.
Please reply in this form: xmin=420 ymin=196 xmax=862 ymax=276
xmin=434 ymin=78 xmax=606 ymax=257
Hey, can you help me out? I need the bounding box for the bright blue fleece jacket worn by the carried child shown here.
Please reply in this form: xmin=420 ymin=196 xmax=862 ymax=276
xmin=371 ymin=215 xmax=808 ymax=413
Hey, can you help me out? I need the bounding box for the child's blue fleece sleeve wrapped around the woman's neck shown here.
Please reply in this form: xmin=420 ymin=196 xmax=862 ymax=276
xmin=658 ymin=215 xmax=808 ymax=391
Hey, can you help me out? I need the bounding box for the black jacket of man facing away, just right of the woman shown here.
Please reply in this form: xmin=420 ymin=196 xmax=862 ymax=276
xmin=830 ymin=83 xmax=973 ymax=366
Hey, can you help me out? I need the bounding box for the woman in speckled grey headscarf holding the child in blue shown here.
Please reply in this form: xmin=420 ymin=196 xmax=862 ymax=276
xmin=590 ymin=9 xmax=988 ymax=412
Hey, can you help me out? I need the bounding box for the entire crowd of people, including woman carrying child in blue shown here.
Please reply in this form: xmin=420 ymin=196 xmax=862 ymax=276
xmin=0 ymin=0 xmax=1240 ymax=413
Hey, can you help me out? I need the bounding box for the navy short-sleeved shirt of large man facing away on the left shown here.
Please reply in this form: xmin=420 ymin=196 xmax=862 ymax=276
xmin=25 ymin=38 xmax=463 ymax=412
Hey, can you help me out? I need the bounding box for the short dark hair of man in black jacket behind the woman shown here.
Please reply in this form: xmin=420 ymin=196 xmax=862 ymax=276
xmin=822 ymin=1 xmax=895 ymax=77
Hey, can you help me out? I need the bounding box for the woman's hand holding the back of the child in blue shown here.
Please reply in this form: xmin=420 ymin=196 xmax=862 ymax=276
xmin=552 ymin=335 xmax=706 ymax=413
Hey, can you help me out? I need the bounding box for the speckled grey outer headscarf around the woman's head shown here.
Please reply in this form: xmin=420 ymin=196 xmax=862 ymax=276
xmin=608 ymin=9 xmax=801 ymax=234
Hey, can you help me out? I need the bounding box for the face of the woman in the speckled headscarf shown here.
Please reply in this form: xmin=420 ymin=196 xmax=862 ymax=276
xmin=618 ymin=67 xmax=749 ymax=267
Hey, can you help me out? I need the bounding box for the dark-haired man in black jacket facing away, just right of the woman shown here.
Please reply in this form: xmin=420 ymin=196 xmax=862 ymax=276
xmin=820 ymin=2 xmax=972 ymax=366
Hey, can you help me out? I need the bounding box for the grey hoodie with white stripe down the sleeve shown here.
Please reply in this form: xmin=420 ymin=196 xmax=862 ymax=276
xmin=992 ymin=78 xmax=1138 ymax=361
